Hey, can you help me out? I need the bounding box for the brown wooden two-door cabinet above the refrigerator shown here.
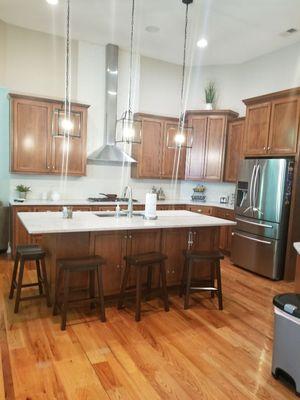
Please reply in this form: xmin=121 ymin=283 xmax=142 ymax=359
xmin=244 ymin=88 xmax=300 ymax=156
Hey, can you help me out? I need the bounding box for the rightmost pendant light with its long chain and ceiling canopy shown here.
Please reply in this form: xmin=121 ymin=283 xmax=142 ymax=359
xmin=167 ymin=0 xmax=193 ymax=149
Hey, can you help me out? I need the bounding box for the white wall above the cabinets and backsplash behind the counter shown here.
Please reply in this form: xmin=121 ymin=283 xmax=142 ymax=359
xmin=0 ymin=21 xmax=300 ymax=203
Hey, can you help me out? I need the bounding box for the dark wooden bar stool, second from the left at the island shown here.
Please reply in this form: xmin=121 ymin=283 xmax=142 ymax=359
xmin=53 ymin=256 xmax=106 ymax=331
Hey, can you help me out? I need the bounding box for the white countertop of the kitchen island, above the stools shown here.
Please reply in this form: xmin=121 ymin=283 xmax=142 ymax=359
xmin=18 ymin=210 xmax=236 ymax=234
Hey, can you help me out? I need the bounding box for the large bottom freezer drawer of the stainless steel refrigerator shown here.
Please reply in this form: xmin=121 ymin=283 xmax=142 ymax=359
xmin=231 ymin=231 xmax=283 ymax=280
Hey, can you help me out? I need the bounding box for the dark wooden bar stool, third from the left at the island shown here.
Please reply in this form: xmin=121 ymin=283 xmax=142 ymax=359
xmin=118 ymin=252 xmax=169 ymax=322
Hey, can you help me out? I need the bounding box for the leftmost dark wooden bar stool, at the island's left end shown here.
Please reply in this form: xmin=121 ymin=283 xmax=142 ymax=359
xmin=9 ymin=245 xmax=51 ymax=313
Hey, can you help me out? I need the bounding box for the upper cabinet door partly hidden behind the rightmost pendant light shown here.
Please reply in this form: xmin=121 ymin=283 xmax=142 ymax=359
xmin=161 ymin=122 xmax=186 ymax=179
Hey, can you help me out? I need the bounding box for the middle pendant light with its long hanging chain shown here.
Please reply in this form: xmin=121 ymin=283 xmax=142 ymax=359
xmin=116 ymin=0 xmax=142 ymax=144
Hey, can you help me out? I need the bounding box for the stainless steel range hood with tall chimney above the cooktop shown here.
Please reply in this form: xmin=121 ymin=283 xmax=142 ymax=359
xmin=88 ymin=44 xmax=136 ymax=164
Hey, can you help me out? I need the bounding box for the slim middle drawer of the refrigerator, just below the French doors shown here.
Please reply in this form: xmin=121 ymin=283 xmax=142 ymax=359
xmin=236 ymin=215 xmax=280 ymax=239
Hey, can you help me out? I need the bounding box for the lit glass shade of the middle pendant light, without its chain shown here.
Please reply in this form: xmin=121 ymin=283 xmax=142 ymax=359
xmin=116 ymin=110 xmax=142 ymax=144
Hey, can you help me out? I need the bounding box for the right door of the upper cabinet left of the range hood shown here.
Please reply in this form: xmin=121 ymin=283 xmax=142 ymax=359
xmin=51 ymin=104 xmax=86 ymax=176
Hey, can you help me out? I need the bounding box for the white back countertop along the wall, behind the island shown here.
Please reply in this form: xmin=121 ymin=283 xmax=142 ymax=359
xmin=10 ymin=199 xmax=234 ymax=210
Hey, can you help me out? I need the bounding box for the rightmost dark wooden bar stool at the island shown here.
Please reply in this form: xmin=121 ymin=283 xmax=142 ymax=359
xmin=180 ymin=250 xmax=224 ymax=310
